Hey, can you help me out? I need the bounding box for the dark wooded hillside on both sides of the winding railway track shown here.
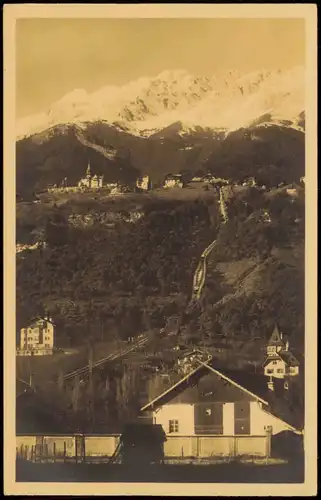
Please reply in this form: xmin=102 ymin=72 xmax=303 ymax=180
xmin=17 ymin=188 xmax=304 ymax=352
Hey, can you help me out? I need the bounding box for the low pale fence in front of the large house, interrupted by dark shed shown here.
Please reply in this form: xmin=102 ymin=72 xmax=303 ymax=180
xmin=16 ymin=433 xmax=271 ymax=463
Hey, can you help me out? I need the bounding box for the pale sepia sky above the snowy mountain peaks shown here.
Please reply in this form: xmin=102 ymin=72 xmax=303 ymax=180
xmin=16 ymin=18 xmax=305 ymax=118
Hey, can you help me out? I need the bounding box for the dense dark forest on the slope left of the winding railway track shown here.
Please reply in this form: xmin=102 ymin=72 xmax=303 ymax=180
xmin=17 ymin=197 xmax=219 ymax=343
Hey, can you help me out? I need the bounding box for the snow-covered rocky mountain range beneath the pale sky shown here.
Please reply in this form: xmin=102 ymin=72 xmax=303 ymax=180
xmin=17 ymin=67 xmax=305 ymax=139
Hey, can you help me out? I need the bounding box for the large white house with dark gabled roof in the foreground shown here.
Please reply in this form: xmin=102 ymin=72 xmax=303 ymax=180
xmin=141 ymin=361 xmax=300 ymax=437
